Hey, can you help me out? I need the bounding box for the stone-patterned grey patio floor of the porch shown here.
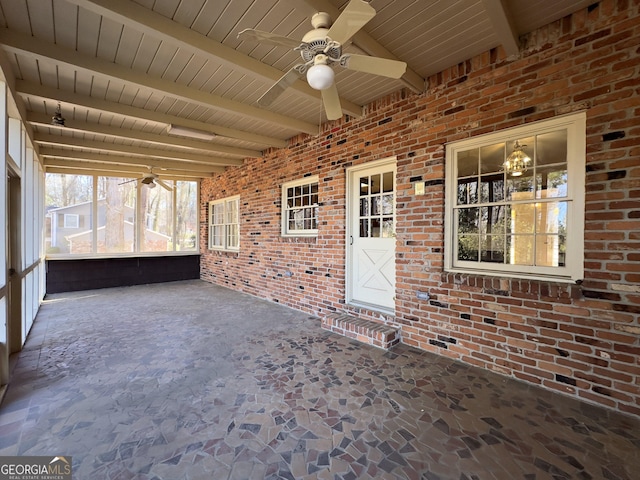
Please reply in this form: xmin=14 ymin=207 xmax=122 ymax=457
xmin=0 ymin=281 xmax=640 ymax=480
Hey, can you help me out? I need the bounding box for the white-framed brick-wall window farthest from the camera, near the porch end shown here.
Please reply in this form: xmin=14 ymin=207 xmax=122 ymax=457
xmin=209 ymin=196 xmax=240 ymax=251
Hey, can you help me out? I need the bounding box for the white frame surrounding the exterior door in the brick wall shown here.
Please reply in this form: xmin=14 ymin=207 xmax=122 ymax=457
xmin=345 ymin=156 xmax=397 ymax=314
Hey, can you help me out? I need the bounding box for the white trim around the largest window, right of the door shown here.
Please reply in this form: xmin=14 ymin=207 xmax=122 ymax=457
xmin=444 ymin=112 xmax=586 ymax=282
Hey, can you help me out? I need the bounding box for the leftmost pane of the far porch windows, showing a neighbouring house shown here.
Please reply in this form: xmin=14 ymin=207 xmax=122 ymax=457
xmin=45 ymin=173 xmax=93 ymax=254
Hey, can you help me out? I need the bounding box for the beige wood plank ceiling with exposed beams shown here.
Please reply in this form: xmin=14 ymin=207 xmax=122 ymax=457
xmin=0 ymin=0 xmax=592 ymax=178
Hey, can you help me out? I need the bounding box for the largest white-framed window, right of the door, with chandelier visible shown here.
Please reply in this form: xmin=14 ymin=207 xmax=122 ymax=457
xmin=445 ymin=113 xmax=586 ymax=281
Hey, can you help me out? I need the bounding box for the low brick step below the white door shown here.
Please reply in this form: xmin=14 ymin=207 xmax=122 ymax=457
xmin=322 ymin=313 xmax=400 ymax=350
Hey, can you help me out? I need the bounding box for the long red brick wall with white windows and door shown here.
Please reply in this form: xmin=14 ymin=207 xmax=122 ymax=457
xmin=201 ymin=0 xmax=640 ymax=415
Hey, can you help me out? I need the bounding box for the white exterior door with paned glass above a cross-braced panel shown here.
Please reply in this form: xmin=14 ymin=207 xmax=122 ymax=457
xmin=347 ymin=158 xmax=396 ymax=312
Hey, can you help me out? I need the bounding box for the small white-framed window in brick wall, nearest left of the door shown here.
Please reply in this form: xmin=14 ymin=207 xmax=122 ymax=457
xmin=282 ymin=176 xmax=318 ymax=237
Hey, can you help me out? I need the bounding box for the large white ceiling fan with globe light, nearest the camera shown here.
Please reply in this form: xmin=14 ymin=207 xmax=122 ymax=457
xmin=238 ymin=0 xmax=407 ymax=120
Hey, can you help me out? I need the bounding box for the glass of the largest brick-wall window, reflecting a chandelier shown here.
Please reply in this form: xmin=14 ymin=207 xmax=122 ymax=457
xmin=453 ymin=125 xmax=569 ymax=267
